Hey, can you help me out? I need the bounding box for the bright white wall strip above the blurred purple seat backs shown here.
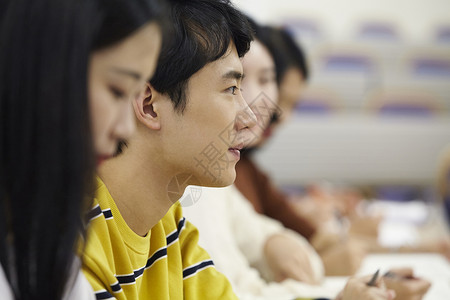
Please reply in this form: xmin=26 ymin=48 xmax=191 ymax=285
xmin=233 ymin=0 xmax=450 ymax=41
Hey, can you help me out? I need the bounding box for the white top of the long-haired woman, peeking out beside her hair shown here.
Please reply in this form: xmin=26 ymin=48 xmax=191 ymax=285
xmin=0 ymin=258 xmax=95 ymax=300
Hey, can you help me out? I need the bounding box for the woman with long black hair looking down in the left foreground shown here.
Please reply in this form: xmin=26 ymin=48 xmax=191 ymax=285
xmin=0 ymin=0 xmax=165 ymax=300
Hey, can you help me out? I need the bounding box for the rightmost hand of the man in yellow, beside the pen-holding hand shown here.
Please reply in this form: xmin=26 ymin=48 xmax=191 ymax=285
xmin=383 ymin=268 xmax=431 ymax=300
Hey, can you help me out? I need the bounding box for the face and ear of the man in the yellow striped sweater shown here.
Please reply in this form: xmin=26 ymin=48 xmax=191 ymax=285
xmin=160 ymin=44 xmax=256 ymax=187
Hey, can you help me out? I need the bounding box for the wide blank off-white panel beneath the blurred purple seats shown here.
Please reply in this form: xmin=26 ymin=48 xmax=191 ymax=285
xmin=256 ymin=114 xmax=450 ymax=185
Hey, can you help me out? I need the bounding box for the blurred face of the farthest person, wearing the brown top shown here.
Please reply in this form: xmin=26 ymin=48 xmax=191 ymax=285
xmin=279 ymin=68 xmax=305 ymax=121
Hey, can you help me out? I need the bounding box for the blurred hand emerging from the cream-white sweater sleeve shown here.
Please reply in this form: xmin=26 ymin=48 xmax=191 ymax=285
xmin=264 ymin=234 xmax=319 ymax=284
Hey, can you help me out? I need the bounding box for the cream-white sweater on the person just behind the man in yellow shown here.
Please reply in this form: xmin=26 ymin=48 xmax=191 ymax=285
xmin=181 ymin=186 xmax=335 ymax=300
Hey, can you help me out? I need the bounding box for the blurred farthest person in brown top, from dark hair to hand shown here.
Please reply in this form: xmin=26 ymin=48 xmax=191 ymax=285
xmin=235 ymin=29 xmax=367 ymax=275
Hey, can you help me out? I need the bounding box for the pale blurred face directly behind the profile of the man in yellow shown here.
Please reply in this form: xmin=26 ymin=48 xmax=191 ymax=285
xmin=242 ymin=40 xmax=278 ymax=147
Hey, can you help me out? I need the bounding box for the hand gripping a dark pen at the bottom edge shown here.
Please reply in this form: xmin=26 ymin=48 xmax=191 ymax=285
xmin=336 ymin=275 xmax=397 ymax=300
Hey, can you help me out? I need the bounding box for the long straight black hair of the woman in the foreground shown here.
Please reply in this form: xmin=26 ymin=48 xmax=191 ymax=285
xmin=0 ymin=0 xmax=164 ymax=300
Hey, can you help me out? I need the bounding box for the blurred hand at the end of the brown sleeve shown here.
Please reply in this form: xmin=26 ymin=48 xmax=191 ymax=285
xmin=320 ymin=239 xmax=367 ymax=276
